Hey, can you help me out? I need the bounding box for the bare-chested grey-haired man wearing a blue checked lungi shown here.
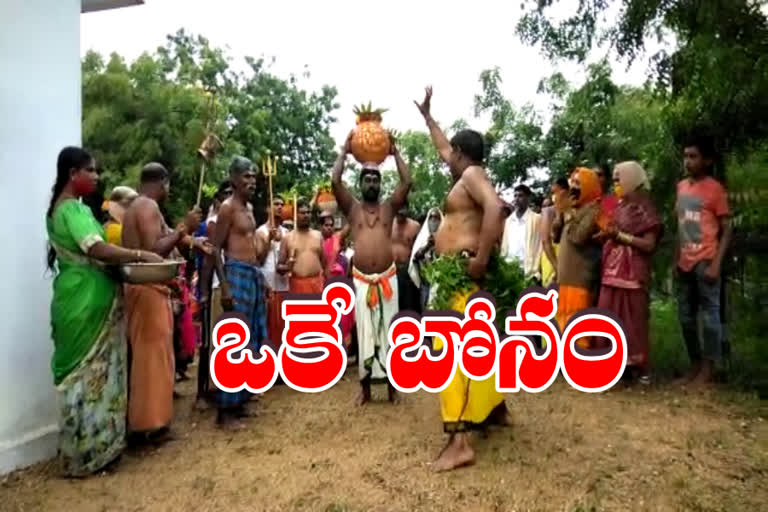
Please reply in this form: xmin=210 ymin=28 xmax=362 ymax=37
xmin=203 ymin=156 xmax=269 ymax=427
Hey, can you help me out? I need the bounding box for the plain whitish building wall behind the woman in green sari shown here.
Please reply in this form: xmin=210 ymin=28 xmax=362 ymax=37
xmin=0 ymin=0 xmax=80 ymax=473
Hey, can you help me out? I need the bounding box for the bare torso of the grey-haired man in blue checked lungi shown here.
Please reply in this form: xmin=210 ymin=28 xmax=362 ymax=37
xmin=216 ymin=196 xmax=267 ymax=265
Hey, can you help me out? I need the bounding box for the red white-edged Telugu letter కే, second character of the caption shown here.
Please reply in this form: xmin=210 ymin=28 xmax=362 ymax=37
xmin=279 ymin=282 xmax=355 ymax=393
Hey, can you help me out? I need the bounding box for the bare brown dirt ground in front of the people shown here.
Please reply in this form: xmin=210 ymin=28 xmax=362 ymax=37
xmin=0 ymin=371 xmax=768 ymax=512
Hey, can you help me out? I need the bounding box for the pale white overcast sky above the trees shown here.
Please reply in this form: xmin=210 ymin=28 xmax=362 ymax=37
xmin=80 ymin=0 xmax=664 ymax=194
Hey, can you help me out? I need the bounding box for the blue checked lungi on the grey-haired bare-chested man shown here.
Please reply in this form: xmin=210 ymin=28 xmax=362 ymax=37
xmin=219 ymin=259 xmax=267 ymax=409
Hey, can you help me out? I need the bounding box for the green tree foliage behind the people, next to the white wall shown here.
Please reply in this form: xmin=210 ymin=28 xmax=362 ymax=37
xmin=82 ymin=30 xmax=337 ymax=220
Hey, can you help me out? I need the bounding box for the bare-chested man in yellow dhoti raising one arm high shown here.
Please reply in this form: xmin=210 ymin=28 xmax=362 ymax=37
xmin=416 ymin=87 xmax=507 ymax=471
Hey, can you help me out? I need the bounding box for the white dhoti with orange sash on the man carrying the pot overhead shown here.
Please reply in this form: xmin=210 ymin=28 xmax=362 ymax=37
xmin=352 ymin=263 xmax=398 ymax=380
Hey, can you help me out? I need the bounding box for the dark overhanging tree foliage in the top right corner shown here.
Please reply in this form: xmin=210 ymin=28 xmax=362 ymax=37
xmin=517 ymin=0 xmax=768 ymax=160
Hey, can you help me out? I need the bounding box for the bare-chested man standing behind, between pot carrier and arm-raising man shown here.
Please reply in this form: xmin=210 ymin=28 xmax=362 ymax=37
xmin=392 ymin=200 xmax=421 ymax=314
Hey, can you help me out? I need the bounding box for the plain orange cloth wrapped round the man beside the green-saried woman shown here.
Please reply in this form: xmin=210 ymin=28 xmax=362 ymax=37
xmin=125 ymin=284 xmax=174 ymax=432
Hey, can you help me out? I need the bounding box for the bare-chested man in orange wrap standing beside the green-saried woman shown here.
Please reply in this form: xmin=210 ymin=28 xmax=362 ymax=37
xmin=122 ymin=163 xmax=207 ymax=440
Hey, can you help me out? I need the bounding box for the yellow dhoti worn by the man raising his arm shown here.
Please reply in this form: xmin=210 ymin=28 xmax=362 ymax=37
xmin=434 ymin=286 xmax=504 ymax=432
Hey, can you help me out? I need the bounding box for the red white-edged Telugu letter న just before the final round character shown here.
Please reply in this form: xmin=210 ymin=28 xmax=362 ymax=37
xmin=496 ymin=290 xmax=561 ymax=393
